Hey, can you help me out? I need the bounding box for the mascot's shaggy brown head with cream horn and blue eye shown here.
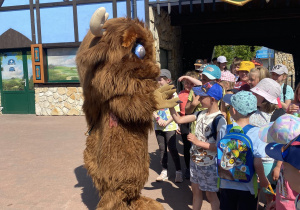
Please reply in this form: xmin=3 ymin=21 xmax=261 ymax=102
xmin=76 ymin=8 xmax=160 ymax=125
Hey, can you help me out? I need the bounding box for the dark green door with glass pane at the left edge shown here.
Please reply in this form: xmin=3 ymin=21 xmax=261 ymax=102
xmin=0 ymin=49 xmax=35 ymax=114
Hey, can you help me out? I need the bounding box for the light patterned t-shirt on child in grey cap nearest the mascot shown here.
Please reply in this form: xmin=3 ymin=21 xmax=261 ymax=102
xmin=154 ymin=93 xmax=180 ymax=131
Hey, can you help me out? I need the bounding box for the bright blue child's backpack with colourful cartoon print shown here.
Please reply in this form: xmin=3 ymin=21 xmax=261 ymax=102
xmin=217 ymin=125 xmax=256 ymax=183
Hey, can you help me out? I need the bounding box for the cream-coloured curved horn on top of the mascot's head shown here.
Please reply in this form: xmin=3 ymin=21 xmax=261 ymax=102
xmin=90 ymin=7 xmax=108 ymax=37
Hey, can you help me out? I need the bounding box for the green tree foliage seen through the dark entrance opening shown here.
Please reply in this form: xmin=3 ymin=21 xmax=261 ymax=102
xmin=214 ymin=45 xmax=261 ymax=65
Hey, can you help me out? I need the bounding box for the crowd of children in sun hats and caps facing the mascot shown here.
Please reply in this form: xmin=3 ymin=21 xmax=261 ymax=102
xmin=153 ymin=56 xmax=300 ymax=210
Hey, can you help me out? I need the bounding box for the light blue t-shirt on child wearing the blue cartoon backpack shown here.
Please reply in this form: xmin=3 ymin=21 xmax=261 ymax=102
xmin=220 ymin=122 xmax=266 ymax=195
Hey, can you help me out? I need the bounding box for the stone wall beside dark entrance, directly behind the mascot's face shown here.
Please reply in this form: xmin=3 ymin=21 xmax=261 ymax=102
xmin=149 ymin=6 xmax=182 ymax=79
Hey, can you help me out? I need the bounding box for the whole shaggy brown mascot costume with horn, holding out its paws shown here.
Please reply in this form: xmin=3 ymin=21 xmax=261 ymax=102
xmin=76 ymin=8 xmax=179 ymax=210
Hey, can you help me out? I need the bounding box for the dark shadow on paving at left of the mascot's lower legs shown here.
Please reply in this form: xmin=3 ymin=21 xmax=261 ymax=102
xmin=74 ymin=165 xmax=100 ymax=210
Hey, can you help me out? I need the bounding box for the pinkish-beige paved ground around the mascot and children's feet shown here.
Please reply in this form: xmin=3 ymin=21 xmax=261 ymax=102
xmin=0 ymin=115 xmax=264 ymax=210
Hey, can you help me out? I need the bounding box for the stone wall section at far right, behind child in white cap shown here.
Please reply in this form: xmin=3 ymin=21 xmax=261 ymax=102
xmin=275 ymin=51 xmax=295 ymax=88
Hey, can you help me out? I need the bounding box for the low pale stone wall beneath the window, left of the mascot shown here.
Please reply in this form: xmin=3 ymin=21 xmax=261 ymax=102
xmin=35 ymin=87 xmax=83 ymax=115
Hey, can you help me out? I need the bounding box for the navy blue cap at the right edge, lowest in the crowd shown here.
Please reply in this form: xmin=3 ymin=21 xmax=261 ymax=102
xmin=265 ymin=136 xmax=300 ymax=170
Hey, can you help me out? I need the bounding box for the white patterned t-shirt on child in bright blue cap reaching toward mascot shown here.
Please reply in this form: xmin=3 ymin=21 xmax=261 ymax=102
xmin=190 ymin=110 xmax=227 ymax=166
